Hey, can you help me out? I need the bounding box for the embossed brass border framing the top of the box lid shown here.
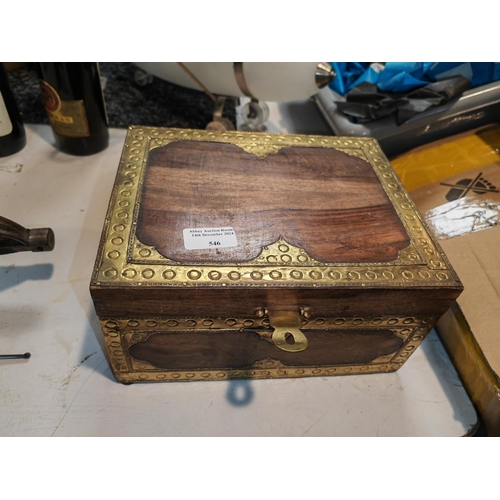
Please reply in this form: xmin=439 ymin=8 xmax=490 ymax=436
xmin=92 ymin=127 xmax=460 ymax=287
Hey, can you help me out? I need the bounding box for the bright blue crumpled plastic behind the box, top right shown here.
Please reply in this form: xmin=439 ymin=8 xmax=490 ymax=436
xmin=330 ymin=62 xmax=500 ymax=95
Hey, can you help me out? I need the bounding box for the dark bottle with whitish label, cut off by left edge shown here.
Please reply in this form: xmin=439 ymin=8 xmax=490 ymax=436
xmin=0 ymin=63 xmax=26 ymax=156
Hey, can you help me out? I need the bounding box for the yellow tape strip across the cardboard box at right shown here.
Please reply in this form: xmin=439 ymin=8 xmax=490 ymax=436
xmin=391 ymin=125 xmax=500 ymax=191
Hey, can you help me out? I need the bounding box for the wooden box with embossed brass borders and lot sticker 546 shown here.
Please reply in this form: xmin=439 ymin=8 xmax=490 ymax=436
xmin=91 ymin=127 xmax=462 ymax=383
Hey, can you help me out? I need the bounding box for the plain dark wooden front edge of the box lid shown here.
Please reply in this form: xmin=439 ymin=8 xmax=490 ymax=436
xmin=91 ymin=286 xmax=461 ymax=318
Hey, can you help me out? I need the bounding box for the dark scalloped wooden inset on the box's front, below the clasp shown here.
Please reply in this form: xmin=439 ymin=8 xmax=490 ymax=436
xmin=129 ymin=329 xmax=403 ymax=370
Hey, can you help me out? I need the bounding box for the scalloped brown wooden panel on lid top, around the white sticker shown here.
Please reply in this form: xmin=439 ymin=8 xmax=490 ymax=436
xmin=137 ymin=141 xmax=409 ymax=263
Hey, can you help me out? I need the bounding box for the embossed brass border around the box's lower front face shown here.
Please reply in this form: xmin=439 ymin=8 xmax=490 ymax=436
xmin=100 ymin=316 xmax=437 ymax=383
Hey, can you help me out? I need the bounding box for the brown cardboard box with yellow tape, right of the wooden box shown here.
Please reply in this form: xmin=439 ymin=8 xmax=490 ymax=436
xmin=392 ymin=126 xmax=500 ymax=436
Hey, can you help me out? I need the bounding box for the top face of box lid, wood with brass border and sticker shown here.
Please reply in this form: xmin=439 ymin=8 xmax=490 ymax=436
xmin=91 ymin=127 xmax=461 ymax=300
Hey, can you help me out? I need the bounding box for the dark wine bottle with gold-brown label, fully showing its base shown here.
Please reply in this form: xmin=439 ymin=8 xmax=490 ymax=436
xmin=37 ymin=62 xmax=109 ymax=156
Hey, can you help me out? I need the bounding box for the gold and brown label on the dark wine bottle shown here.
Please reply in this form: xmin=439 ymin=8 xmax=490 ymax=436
xmin=40 ymin=80 xmax=90 ymax=137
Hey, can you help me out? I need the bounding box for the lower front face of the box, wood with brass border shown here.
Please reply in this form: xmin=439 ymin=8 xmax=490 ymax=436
xmin=101 ymin=316 xmax=436 ymax=383
